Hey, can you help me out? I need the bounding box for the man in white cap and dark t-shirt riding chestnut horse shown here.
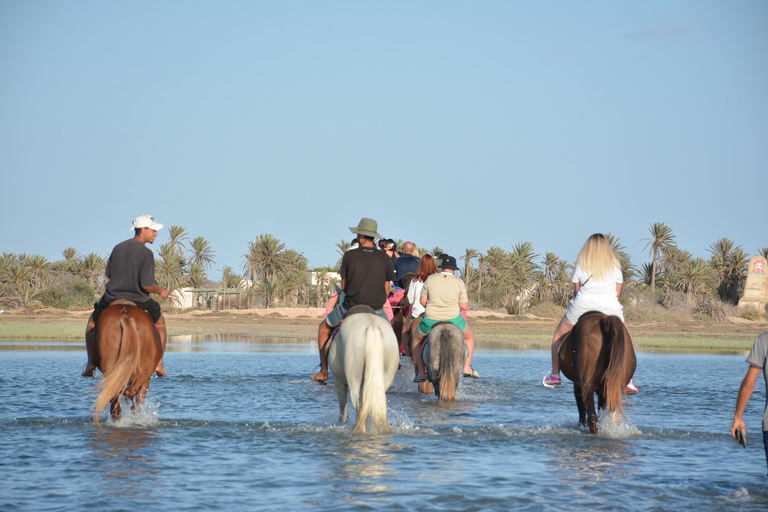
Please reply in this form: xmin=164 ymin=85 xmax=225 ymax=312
xmin=83 ymin=215 xmax=170 ymax=377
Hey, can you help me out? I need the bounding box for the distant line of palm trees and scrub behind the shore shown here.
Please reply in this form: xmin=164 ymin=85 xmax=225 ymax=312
xmin=0 ymin=223 xmax=768 ymax=317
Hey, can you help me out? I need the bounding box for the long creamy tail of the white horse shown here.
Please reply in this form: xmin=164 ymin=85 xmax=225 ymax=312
xmin=353 ymin=325 xmax=392 ymax=434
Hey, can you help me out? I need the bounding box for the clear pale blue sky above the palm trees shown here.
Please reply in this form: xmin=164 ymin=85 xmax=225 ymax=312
xmin=0 ymin=0 xmax=768 ymax=278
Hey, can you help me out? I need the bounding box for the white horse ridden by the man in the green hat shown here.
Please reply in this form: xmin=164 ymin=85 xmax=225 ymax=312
xmin=328 ymin=306 xmax=400 ymax=433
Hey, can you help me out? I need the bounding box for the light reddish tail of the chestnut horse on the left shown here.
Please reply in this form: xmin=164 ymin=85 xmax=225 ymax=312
xmin=93 ymin=314 xmax=141 ymax=425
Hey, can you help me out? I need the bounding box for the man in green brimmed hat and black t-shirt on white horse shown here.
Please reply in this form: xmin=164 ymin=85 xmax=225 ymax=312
xmin=312 ymin=218 xmax=395 ymax=383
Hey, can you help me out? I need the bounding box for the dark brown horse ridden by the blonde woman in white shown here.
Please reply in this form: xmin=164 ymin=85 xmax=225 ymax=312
xmin=559 ymin=311 xmax=637 ymax=434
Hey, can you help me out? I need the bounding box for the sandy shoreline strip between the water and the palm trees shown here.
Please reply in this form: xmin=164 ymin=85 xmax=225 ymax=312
xmin=0 ymin=308 xmax=768 ymax=352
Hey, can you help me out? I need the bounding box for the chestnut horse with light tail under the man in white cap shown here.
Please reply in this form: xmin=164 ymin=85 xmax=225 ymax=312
xmin=93 ymin=300 xmax=163 ymax=425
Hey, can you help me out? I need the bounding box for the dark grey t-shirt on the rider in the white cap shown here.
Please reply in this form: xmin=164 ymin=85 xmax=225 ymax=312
xmin=104 ymin=238 xmax=155 ymax=302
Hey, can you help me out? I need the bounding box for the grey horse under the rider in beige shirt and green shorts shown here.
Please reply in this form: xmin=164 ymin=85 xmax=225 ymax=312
xmin=423 ymin=322 xmax=469 ymax=402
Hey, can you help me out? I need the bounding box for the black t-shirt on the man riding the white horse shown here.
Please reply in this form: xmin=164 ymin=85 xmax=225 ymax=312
xmin=341 ymin=247 xmax=395 ymax=309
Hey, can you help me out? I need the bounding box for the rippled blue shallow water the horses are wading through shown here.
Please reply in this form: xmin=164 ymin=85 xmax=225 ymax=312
xmin=0 ymin=337 xmax=768 ymax=512
